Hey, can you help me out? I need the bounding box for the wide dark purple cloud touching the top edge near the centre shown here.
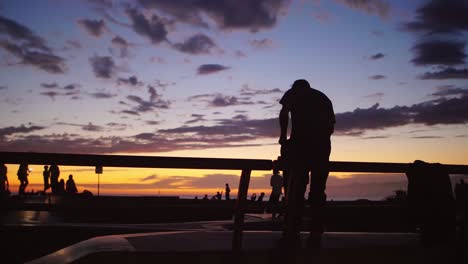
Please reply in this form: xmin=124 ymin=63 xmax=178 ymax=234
xmin=139 ymin=0 xmax=289 ymax=32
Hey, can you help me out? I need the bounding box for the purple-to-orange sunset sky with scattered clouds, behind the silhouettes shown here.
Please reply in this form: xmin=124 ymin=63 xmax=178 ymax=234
xmin=0 ymin=0 xmax=468 ymax=199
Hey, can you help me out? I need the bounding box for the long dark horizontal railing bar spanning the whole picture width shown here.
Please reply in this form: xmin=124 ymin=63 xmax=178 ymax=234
xmin=0 ymin=152 xmax=468 ymax=174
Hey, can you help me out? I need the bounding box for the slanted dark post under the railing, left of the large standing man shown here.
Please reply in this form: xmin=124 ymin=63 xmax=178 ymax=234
xmin=232 ymin=170 xmax=251 ymax=251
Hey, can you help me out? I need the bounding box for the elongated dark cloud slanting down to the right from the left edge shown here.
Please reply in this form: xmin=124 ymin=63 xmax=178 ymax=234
xmin=0 ymin=16 xmax=66 ymax=74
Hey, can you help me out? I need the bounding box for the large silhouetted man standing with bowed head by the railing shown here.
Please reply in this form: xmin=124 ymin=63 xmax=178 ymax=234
xmin=279 ymin=80 xmax=335 ymax=246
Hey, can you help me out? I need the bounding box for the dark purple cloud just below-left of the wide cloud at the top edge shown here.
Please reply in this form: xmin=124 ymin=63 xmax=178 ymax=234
xmin=126 ymin=9 xmax=168 ymax=44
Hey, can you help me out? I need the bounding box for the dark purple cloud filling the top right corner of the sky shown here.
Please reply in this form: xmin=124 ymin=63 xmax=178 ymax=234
xmin=404 ymin=0 xmax=468 ymax=34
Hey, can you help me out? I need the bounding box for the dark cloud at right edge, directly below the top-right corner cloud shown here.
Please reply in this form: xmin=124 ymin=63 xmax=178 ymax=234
xmin=411 ymin=40 xmax=466 ymax=66
